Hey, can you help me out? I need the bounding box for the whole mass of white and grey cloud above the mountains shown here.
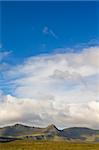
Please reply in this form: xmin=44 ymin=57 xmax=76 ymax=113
xmin=0 ymin=47 xmax=99 ymax=128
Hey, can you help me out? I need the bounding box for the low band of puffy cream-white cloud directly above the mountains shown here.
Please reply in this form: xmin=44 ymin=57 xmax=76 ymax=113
xmin=0 ymin=95 xmax=99 ymax=128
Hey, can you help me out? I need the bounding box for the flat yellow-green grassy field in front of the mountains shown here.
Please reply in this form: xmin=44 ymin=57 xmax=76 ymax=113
xmin=0 ymin=141 xmax=99 ymax=150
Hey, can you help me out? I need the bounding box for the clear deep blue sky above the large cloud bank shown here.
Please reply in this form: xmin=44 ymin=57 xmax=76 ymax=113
xmin=0 ymin=1 xmax=99 ymax=59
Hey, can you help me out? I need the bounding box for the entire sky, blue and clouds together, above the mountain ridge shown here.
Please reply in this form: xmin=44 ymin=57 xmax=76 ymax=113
xmin=0 ymin=1 xmax=99 ymax=128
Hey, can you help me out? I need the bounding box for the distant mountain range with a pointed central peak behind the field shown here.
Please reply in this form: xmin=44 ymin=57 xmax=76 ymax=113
xmin=0 ymin=124 xmax=99 ymax=142
